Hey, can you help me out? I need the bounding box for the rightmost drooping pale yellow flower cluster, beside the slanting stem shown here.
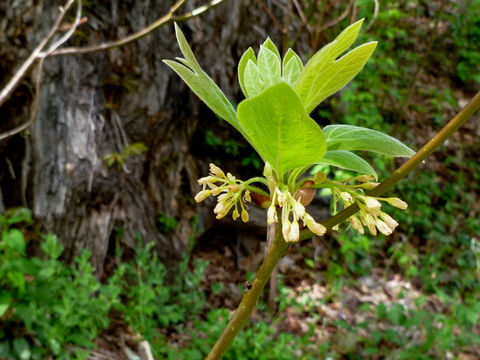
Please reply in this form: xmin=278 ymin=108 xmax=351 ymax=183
xmin=331 ymin=175 xmax=408 ymax=235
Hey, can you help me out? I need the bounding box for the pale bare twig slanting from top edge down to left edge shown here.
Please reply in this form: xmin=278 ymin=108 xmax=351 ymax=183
xmin=0 ymin=0 xmax=75 ymax=106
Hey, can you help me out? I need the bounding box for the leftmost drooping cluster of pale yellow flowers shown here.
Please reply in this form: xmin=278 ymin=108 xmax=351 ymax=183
xmin=195 ymin=164 xmax=251 ymax=222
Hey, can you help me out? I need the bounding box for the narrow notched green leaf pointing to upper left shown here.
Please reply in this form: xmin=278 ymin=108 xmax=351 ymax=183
xmin=163 ymin=24 xmax=245 ymax=141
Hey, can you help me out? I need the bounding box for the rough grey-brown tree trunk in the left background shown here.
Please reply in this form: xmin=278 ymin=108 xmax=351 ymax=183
xmin=0 ymin=0 xmax=279 ymax=275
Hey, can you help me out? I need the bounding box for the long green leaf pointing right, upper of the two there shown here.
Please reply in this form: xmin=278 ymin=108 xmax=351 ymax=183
xmin=323 ymin=125 xmax=415 ymax=157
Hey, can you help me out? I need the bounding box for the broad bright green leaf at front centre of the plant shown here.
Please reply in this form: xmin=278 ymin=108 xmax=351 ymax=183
xmin=238 ymin=81 xmax=326 ymax=176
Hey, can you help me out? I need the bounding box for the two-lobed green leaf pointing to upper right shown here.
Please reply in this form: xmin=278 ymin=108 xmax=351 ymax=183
xmin=294 ymin=19 xmax=377 ymax=113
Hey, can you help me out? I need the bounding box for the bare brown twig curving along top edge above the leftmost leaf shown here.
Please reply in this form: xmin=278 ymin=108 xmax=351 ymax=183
xmin=44 ymin=0 xmax=225 ymax=56
